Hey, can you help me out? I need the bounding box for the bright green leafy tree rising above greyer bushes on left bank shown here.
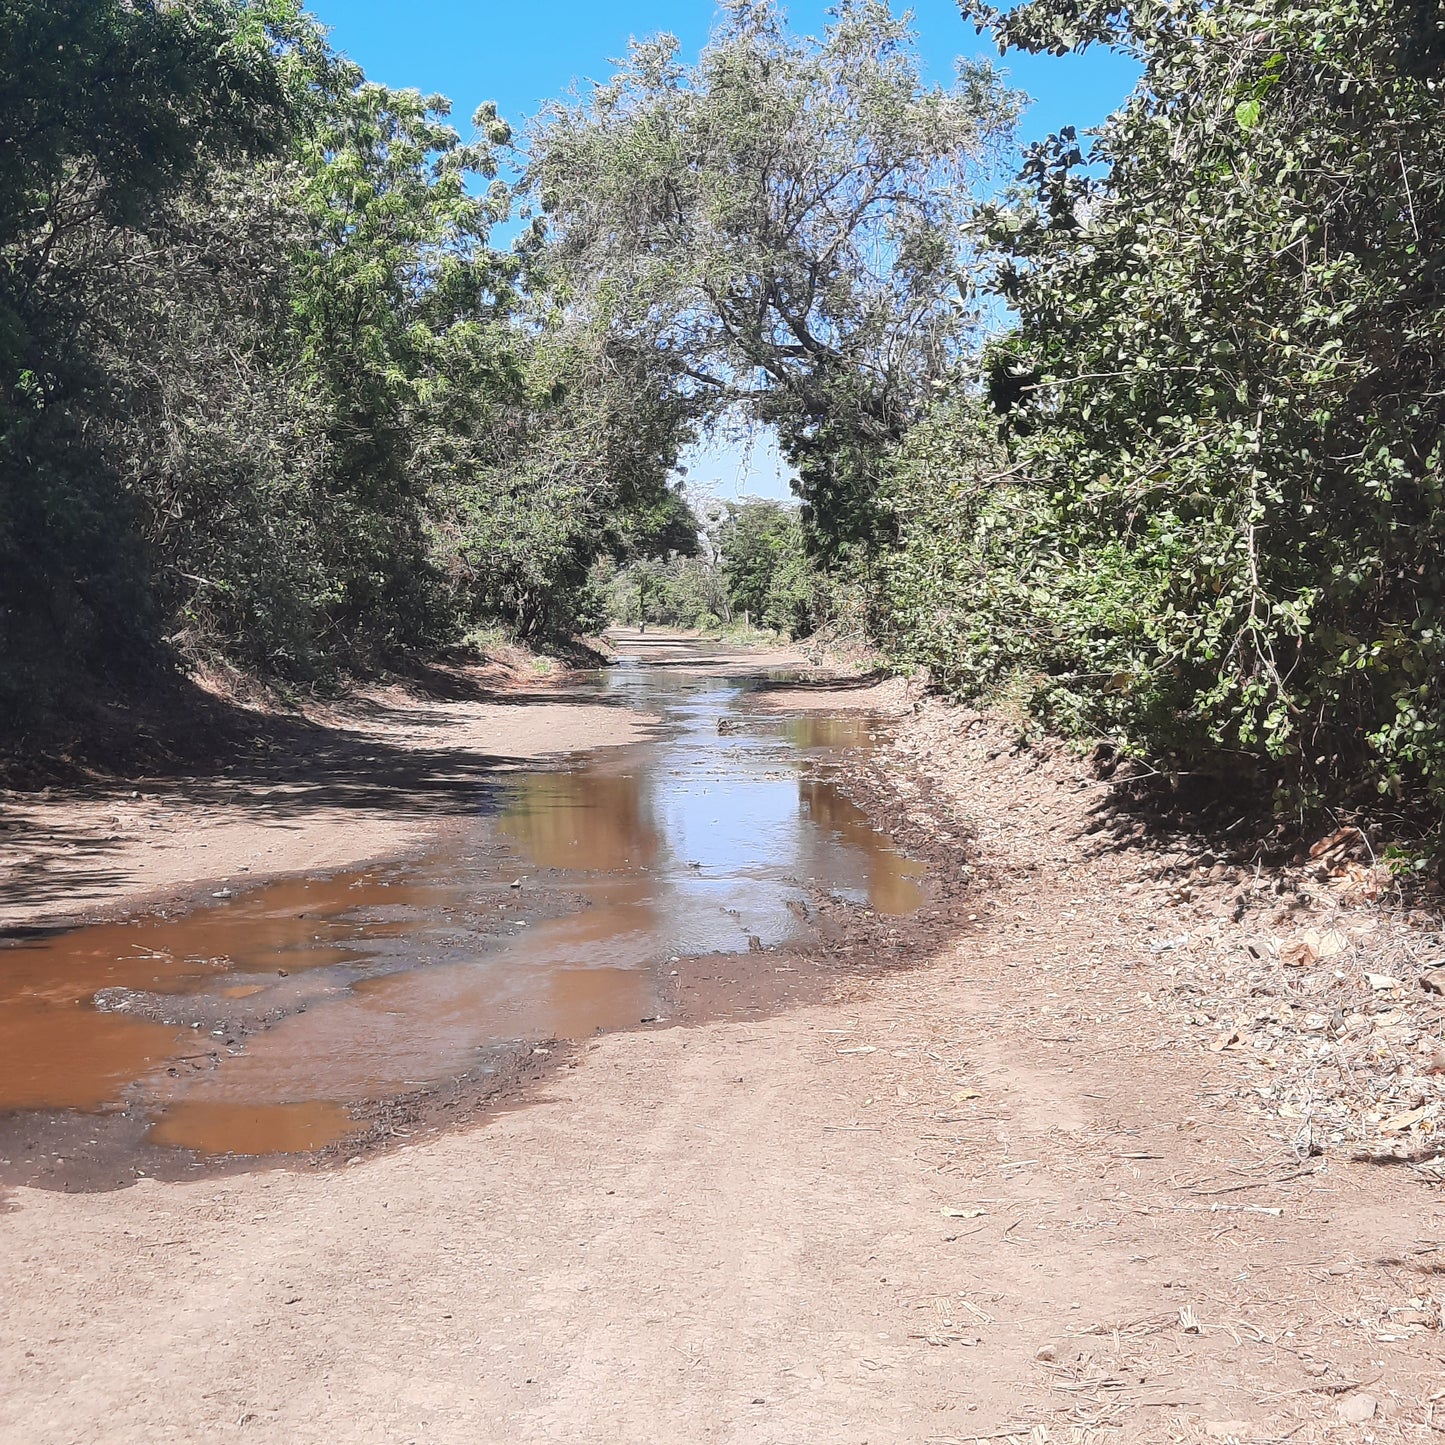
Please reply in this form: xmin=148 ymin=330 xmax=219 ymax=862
xmin=274 ymin=76 xmax=525 ymax=661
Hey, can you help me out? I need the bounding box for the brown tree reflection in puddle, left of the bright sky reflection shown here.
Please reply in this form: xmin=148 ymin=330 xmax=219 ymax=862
xmin=501 ymin=769 xmax=662 ymax=870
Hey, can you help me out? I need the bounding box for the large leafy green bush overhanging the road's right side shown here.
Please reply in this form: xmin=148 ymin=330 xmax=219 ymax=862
xmin=901 ymin=0 xmax=1445 ymax=808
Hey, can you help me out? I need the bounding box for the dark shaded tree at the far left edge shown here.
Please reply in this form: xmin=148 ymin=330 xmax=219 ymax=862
xmin=0 ymin=0 xmax=305 ymax=702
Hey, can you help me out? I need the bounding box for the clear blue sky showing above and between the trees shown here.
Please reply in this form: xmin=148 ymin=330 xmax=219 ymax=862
xmin=309 ymin=0 xmax=1136 ymax=497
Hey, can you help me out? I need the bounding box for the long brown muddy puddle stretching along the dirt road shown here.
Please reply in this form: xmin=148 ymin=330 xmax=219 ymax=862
xmin=0 ymin=663 xmax=923 ymax=1172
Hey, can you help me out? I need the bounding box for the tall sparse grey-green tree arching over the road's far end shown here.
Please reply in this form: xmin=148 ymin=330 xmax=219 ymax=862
xmin=527 ymin=0 xmax=1016 ymax=546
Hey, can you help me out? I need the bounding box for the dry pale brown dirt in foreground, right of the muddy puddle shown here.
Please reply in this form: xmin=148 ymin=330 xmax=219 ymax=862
xmin=0 ymin=647 xmax=1445 ymax=1445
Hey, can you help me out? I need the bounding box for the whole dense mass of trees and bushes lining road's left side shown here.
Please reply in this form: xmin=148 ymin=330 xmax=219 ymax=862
xmin=0 ymin=0 xmax=691 ymax=723
